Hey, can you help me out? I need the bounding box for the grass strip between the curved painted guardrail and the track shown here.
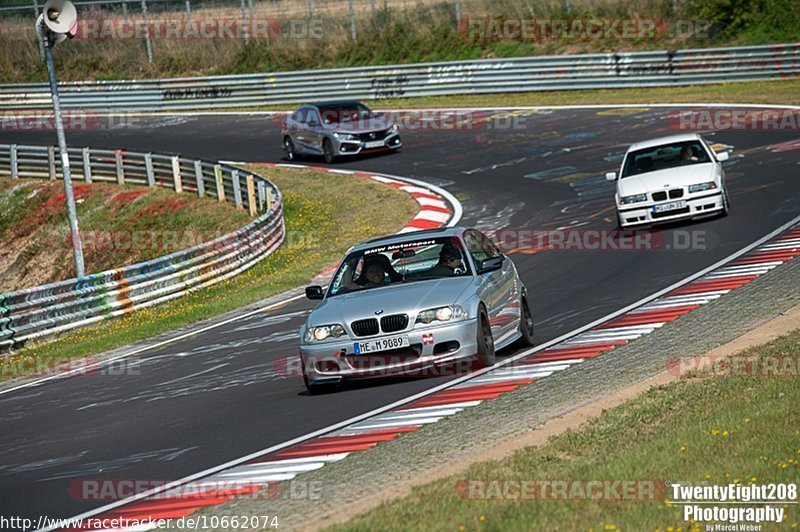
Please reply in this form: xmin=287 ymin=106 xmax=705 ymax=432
xmin=0 ymin=165 xmax=418 ymax=380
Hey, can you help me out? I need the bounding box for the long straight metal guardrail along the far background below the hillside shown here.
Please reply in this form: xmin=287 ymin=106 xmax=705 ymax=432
xmin=0 ymin=43 xmax=800 ymax=110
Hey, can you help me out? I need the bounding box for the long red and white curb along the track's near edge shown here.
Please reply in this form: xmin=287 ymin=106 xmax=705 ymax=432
xmin=50 ymin=215 xmax=800 ymax=530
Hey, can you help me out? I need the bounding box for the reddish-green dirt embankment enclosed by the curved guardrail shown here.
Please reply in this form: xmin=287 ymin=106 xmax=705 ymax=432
xmin=0 ymin=178 xmax=249 ymax=293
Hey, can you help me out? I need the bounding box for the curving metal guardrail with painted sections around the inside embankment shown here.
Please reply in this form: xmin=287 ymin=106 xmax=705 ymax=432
xmin=0 ymin=144 xmax=285 ymax=350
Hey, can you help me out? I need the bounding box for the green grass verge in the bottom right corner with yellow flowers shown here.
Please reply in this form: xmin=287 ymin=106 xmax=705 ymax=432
xmin=331 ymin=330 xmax=800 ymax=531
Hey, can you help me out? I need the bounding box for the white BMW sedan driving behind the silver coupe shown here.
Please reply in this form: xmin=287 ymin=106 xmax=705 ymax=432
xmin=606 ymin=133 xmax=728 ymax=228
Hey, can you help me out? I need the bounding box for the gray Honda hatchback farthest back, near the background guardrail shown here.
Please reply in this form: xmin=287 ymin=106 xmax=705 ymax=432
xmin=281 ymin=101 xmax=403 ymax=163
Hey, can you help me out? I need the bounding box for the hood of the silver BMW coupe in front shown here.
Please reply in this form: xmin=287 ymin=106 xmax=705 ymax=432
xmin=308 ymin=276 xmax=478 ymax=327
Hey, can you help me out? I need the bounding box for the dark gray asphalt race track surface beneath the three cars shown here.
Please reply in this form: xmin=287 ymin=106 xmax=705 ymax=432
xmin=0 ymin=108 xmax=800 ymax=518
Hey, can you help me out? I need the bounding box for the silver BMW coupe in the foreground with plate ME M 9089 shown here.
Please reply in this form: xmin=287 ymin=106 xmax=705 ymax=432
xmin=300 ymin=227 xmax=533 ymax=393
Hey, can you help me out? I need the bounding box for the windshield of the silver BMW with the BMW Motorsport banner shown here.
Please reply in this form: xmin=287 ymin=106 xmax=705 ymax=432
xmin=328 ymin=237 xmax=471 ymax=297
